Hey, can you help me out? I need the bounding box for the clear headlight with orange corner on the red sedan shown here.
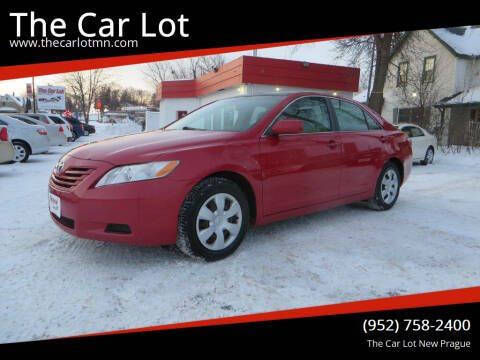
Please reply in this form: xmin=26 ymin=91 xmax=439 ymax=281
xmin=95 ymin=160 xmax=180 ymax=187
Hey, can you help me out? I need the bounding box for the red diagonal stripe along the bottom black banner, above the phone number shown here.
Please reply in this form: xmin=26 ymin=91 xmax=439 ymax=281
xmin=73 ymin=286 xmax=480 ymax=338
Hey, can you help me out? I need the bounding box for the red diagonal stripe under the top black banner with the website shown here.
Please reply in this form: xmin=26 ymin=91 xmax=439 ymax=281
xmin=0 ymin=36 xmax=352 ymax=80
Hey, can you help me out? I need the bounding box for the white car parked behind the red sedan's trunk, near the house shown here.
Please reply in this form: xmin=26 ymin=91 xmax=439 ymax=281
xmin=398 ymin=124 xmax=437 ymax=165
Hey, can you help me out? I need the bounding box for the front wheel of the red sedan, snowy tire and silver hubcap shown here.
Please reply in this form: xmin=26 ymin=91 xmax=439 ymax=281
xmin=177 ymin=177 xmax=250 ymax=261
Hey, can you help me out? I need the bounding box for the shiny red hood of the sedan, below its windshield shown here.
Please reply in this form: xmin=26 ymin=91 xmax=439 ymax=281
xmin=68 ymin=130 xmax=234 ymax=165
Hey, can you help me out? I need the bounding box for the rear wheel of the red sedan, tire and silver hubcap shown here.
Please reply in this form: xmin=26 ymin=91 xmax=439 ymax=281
xmin=368 ymin=162 xmax=400 ymax=211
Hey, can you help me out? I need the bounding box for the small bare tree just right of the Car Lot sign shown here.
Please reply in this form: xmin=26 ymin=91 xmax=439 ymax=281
xmin=63 ymin=69 xmax=105 ymax=124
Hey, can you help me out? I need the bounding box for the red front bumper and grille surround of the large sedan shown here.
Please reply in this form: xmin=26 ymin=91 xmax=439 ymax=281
xmin=49 ymin=156 xmax=191 ymax=246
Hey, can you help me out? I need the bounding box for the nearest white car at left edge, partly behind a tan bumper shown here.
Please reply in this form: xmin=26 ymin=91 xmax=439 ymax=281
xmin=0 ymin=114 xmax=50 ymax=162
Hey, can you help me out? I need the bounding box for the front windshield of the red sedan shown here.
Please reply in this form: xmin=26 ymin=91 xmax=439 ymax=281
xmin=166 ymin=95 xmax=285 ymax=131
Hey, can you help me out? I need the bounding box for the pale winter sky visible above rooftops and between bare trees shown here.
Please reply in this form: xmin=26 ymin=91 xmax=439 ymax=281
xmin=0 ymin=41 xmax=347 ymax=96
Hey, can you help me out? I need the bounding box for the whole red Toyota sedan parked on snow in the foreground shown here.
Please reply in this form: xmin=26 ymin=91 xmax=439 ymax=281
xmin=49 ymin=93 xmax=412 ymax=260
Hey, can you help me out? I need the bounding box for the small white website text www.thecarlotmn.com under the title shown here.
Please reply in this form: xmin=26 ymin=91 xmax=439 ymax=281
xmin=10 ymin=38 xmax=138 ymax=48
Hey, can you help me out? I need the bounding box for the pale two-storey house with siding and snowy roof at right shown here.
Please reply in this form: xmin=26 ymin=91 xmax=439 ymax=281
xmin=382 ymin=26 xmax=480 ymax=145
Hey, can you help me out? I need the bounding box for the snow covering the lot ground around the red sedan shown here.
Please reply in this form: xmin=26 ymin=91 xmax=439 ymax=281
xmin=0 ymin=124 xmax=480 ymax=342
